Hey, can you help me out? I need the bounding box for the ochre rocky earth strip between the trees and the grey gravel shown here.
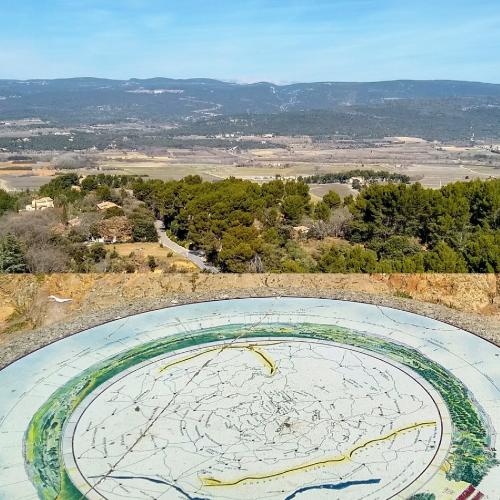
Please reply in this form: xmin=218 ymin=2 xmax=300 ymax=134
xmin=0 ymin=274 xmax=500 ymax=334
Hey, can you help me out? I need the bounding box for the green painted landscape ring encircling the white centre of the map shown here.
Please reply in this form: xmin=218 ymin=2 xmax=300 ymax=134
xmin=25 ymin=324 xmax=496 ymax=500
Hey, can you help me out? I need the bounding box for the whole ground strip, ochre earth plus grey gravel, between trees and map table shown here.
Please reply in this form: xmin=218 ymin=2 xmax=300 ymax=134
xmin=0 ymin=273 xmax=500 ymax=367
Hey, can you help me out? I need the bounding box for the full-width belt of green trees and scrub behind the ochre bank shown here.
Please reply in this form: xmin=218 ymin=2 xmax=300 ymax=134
xmin=0 ymin=174 xmax=500 ymax=273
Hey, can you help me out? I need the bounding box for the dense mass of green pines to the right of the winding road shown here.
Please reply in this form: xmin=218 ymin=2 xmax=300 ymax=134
xmin=134 ymin=176 xmax=500 ymax=272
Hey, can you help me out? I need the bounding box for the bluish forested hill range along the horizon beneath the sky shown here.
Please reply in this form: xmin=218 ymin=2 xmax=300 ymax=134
xmin=0 ymin=78 xmax=500 ymax=139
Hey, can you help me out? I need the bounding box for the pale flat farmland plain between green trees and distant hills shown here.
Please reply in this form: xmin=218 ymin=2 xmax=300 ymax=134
xmin=0 ymin=137 xmax=500 ymax=191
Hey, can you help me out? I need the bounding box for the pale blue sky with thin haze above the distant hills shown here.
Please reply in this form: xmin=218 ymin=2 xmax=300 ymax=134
xmin=0 ymin=0 xmax=500 ymax=83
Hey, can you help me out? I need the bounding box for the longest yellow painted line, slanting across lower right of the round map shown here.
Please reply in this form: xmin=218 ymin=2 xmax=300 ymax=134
xmin=200 ymin=422 xmax=436 ymax=486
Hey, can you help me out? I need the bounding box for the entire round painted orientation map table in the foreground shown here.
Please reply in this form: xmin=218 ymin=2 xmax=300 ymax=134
xmin=0 ymin=298 xmax=500 ymax=500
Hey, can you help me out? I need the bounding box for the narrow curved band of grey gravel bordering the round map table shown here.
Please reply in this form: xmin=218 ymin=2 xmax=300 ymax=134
xmin=0 ymin=288 xmax=500 ymax=369
